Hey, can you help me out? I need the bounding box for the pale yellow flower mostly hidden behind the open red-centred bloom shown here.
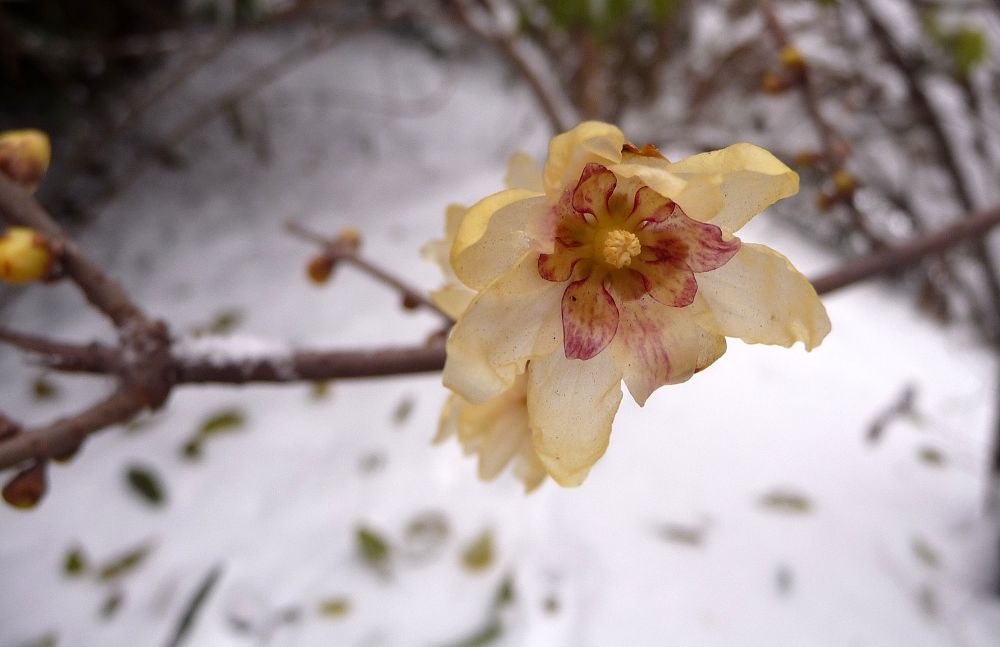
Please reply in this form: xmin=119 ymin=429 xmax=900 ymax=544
xmin=421 ymin=153 xmax=546 ymax=492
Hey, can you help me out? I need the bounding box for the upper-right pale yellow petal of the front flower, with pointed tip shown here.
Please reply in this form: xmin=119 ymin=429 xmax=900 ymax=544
xmin=653 ymin=144 xmax=799 ymax=232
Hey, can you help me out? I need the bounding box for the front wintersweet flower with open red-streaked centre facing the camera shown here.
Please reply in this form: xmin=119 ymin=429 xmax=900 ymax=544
xmin=444 ymin=122 xmax=830 ymax=486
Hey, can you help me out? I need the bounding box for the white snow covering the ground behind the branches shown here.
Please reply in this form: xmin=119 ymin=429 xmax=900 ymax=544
xmin=0 ymin=33 xmax=1000 ymax=647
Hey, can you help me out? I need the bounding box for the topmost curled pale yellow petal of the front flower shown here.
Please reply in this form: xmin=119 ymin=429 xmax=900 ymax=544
xmin=544 ymin=121 xmax=625 ymax=197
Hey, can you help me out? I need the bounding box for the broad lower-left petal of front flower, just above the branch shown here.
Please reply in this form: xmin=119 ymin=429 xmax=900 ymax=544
xmin=443 ymin=253 xmax=566 ymax=403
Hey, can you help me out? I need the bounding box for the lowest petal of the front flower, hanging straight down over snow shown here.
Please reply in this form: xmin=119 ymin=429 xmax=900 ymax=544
xmin=528 ymin=351 xmax=622 ymax=487
